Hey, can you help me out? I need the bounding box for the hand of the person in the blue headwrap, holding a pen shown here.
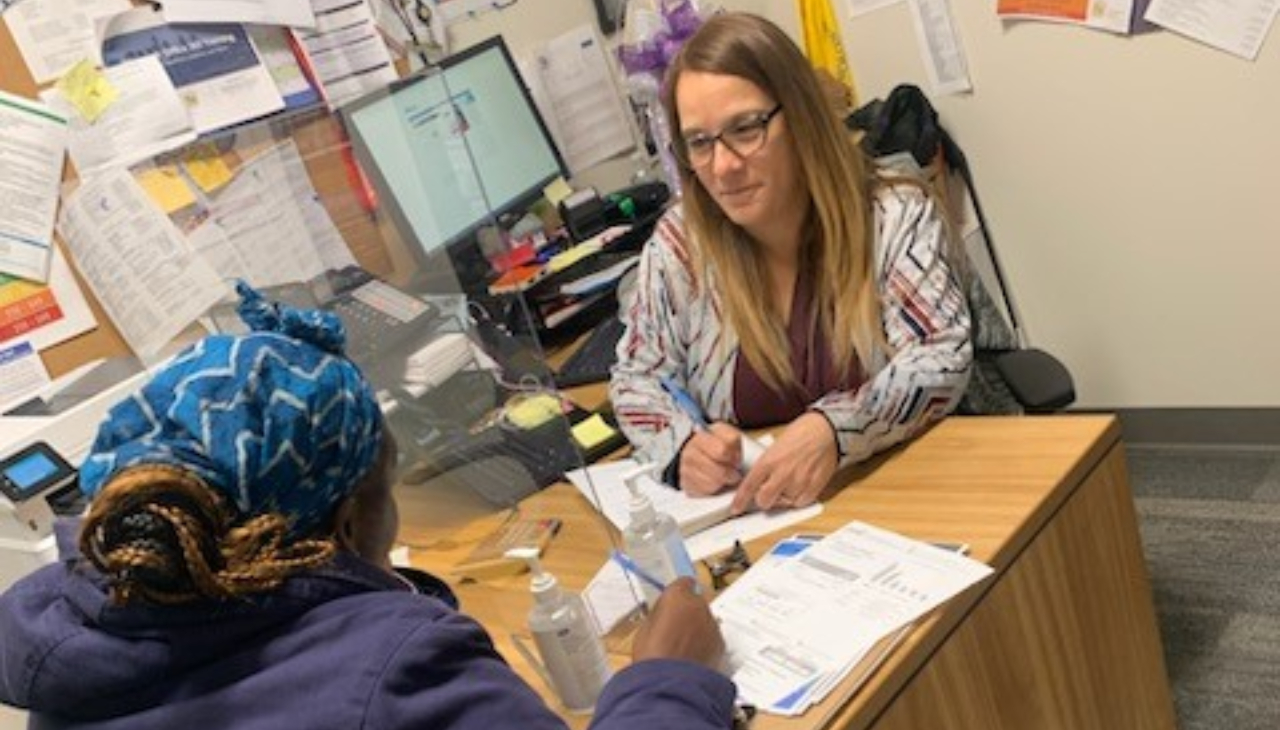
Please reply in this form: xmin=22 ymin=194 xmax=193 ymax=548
xmin=631 ymin=578 xmax=724 ymax=670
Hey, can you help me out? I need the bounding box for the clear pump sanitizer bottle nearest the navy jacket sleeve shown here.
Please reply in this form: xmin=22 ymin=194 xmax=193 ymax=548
xmin=506 ymin=548 xmax=611 ymax=712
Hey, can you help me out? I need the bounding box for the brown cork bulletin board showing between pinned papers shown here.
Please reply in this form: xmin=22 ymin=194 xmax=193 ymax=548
xmin=0 ymin=5 xmax=407 ymax=378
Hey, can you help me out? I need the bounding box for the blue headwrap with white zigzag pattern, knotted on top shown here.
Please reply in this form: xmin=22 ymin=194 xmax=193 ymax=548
xmin=79 ymin=283 xmax=383 ymax=535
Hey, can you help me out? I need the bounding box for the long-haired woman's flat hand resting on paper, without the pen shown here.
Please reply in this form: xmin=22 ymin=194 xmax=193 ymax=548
xmin=732 ymin=411 xmax=840 ymax=515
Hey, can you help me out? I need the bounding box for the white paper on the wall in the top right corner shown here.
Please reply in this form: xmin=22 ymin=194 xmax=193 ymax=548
xmin=1143 ymin=0 xmax=1280 ymax=60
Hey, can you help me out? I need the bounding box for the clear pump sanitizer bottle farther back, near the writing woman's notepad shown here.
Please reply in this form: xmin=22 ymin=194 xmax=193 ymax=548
xmin=622 ymin=464 xmax=698 ymax=608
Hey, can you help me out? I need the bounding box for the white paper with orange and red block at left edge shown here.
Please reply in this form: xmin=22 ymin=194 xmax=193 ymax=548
xmin=0 ymin=246 xmax=97 ymax=350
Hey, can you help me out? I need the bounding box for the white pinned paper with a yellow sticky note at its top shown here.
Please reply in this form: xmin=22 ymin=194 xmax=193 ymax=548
xmin=41 ymin=56 xmax=196 ymax=177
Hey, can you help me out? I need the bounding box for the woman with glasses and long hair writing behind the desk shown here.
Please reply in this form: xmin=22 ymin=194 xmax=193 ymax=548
xmin=611 ymin=13 xmax=972 ymax=511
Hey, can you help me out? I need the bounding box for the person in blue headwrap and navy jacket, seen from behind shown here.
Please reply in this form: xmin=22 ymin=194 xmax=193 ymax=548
xmin=0 ymin=286 xmax=735 ymax=730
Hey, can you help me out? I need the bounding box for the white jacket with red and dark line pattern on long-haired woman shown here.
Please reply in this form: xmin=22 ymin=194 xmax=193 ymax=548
xmin=609 ymin=184 xmax=973 ymax=466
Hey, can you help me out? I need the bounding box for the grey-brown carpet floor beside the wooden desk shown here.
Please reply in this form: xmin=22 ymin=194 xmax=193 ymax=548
xmin=1128 ymin=446 xmax=1280 ymax=730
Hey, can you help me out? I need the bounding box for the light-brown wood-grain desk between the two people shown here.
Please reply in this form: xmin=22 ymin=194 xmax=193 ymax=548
xmin=402 ymin=416 xmax=1176 ymax=730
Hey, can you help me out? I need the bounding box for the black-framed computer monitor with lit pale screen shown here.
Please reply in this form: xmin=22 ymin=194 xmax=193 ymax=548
xmin=342 ymin=36 xmax=568 ymax=286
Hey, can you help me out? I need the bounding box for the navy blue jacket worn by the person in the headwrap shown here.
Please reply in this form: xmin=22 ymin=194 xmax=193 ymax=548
xmin=0 ymin=535 xmax=733 ymax=730
